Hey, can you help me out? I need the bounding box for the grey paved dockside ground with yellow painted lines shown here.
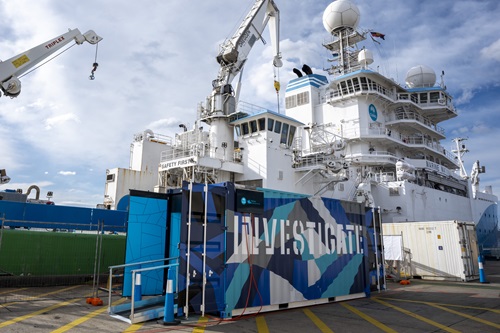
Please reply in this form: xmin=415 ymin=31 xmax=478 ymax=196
xmin=0 ymin=260 xmax=500 ymax=333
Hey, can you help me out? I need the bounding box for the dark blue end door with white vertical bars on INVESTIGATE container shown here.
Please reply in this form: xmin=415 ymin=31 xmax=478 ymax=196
xmin=179 ymin=184 xmax=227 ymax=314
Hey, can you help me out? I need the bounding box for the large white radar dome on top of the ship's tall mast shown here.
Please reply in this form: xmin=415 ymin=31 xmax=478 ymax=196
xmin=323 ymin=0 xmax=359 ymax=33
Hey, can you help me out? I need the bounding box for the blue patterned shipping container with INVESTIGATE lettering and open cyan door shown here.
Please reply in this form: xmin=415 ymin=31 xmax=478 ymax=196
xmin=124 ymin=183 xmax=384 ymax=318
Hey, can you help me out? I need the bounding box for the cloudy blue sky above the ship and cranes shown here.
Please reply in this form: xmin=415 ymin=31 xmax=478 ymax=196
xmin=0 ymin=0 xmax=500 ymax=207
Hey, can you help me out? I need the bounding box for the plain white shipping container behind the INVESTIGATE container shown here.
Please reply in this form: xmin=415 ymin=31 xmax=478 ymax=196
xmin=382 ymin=221 xmax=479 ymax=281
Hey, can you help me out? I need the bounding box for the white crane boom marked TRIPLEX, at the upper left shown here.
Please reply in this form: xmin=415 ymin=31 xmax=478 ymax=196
xmin=0 ymin=29 xmax=102 ymax=97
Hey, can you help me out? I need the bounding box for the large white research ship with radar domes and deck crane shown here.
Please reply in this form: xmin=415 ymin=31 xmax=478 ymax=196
xmin=104 ymin=0 xmax=498 ymax=248
